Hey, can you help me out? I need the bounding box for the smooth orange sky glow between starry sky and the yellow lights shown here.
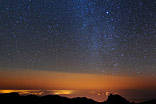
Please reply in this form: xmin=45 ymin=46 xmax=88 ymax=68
xmin=0 ymin=70 xmax=156 ymax=90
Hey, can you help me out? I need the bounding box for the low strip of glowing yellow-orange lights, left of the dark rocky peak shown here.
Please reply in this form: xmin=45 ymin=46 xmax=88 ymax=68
xmin=0 ymin=90 xmax=113 ymax=102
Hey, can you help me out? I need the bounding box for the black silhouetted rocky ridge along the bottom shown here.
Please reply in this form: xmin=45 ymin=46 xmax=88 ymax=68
xmin=0 ymin=93 xmax=156 ymax=104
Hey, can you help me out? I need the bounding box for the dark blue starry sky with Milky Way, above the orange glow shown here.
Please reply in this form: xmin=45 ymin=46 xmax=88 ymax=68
xmin=0 ymin=0 xmax=156 ymax=76
